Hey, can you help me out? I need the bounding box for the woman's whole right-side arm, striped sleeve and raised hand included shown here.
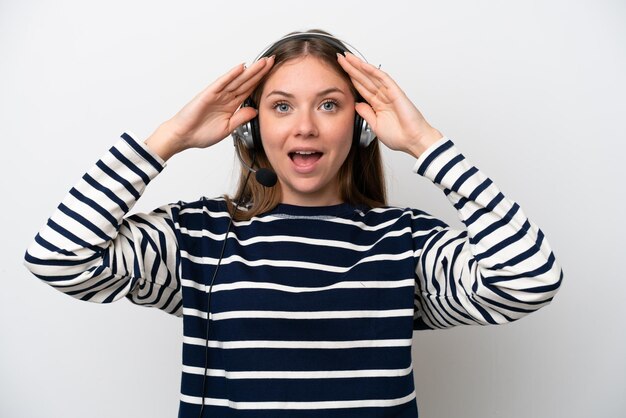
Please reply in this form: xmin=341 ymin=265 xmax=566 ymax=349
xmin=337 ymin=53 xmax=563 ymax=329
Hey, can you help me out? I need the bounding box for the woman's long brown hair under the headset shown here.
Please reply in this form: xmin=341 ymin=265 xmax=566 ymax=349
xmin=224 ymin=30 xmax=387 ymax=220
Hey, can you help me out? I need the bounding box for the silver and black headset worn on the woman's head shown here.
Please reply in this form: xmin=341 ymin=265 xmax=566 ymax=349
xmin=232 ymin=32 xmax=376 ymax=165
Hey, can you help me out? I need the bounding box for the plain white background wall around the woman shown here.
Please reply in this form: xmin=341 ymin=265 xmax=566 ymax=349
xmin=0 ymin=0 xmax=626 ymax=418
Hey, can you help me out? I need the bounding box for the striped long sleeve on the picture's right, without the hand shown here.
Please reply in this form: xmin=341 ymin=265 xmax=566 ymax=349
xmin=413 ymin=137 xmax=563 ymax=329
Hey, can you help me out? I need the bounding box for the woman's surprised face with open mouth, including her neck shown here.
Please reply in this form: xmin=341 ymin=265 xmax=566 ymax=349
xmin=259 ymin=55 xmax=355 ymax=206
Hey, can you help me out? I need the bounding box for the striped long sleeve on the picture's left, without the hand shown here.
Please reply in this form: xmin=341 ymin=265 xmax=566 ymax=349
xmin=24 ymin=133 xmax=182 ymax=316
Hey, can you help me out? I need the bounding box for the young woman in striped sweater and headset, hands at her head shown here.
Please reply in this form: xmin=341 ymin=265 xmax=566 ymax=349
xmin=25 ymin=31 xmax=562 ymax=418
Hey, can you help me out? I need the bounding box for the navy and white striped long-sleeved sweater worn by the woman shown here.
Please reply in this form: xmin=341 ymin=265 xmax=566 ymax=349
xmin=24 ymin=133 xmax=563 ymax=418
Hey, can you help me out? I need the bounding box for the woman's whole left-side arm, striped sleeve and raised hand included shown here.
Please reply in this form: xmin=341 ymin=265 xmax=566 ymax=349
xmin=24 ymin=58 xmax=273 ymax=316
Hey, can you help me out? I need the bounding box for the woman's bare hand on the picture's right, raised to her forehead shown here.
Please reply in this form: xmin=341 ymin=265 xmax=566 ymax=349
xmin=337 ymin=52 xmax=443 ymax=158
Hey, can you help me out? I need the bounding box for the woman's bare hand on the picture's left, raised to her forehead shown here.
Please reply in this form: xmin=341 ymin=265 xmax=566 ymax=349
xmin=145 ymin=57 xmax=274 ymax=160
